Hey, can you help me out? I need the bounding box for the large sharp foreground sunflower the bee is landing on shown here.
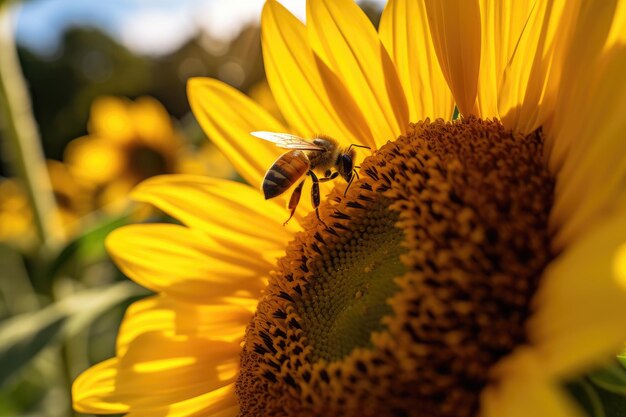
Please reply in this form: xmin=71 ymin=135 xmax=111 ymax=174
xmin=73 ymin=0 xmax=626 ymax=417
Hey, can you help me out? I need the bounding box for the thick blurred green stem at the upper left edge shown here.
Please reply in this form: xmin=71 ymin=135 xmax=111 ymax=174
xmin=0 ymin=2 xmax=64 ymax=249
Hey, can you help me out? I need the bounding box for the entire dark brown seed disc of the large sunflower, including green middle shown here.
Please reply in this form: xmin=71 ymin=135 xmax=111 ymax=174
xmin=237 ymin=118 xmax=553 ymax=417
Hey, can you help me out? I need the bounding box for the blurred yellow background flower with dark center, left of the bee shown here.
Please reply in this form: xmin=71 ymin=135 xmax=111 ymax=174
xmin=64 ymin=96 xmax=200 ymax=210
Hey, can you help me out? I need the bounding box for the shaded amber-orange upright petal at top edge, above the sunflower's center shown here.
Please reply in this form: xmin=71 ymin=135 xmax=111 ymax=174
xmin=426 ymin=0 xmax=481 ymax=116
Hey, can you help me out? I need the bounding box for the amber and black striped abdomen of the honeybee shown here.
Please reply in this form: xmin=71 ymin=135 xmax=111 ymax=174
xmin=262 ymin=150 xmax=309 ymax=200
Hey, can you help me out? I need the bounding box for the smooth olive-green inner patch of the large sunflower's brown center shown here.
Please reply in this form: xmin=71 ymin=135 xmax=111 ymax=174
xmin=293 ymin=195 xmax=405 ymax=360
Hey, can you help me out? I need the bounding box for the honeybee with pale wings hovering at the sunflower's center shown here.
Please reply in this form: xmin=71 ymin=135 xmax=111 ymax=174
xmin=250 ymin=132 xmax=370 ymax=225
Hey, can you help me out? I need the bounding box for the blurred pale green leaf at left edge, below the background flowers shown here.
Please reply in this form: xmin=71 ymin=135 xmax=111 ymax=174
xmin=0 ymin=281 xmax=147 ymax=387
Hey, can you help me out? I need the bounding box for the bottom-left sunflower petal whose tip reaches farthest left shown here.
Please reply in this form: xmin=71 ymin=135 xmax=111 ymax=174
xmin=72 ymin=333 xmax=240 ymax=416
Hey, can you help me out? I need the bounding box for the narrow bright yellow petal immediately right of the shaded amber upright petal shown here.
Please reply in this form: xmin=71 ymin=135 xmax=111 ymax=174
xmin=478 ymin=0 xmax=535 ymax=119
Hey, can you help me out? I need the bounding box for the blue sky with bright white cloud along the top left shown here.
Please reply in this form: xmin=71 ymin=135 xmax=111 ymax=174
xmin=16 ymin=0 xmax=384 ymax=55
